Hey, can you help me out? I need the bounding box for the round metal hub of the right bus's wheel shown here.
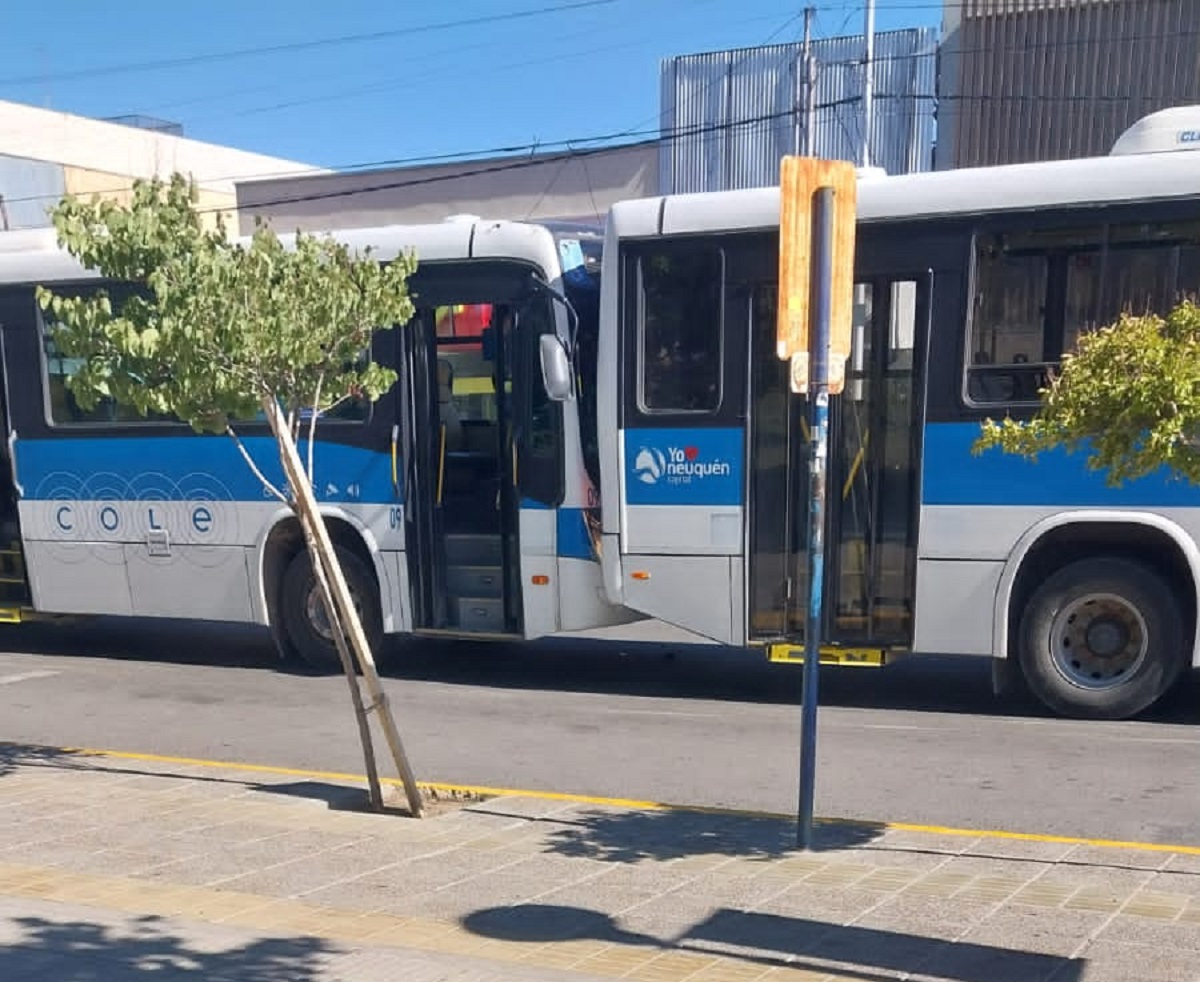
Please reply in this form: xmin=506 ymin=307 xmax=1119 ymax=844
xmin=1050 ymin=593 xmax=1147 ymax=690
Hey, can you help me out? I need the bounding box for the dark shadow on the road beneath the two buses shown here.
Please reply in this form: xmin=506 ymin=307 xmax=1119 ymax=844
xmin=0 ymin=618 xmax=1200 ymax=723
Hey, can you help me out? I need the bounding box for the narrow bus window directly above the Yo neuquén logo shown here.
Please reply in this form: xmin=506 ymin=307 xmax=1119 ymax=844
xmin=637 ymin=244 xmax=725 ymax=413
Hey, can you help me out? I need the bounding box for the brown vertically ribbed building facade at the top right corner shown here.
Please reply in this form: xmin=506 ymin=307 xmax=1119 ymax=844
xmin=937 ymin=0 xmax=1200 ymax=168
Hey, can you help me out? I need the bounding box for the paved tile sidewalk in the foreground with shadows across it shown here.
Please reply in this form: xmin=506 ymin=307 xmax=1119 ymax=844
xmin=0 ymin=744 xmax=1200 ymax=982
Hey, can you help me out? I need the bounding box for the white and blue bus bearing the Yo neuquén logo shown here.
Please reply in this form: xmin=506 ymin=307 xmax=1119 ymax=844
xmin=598 ymin=110 xmax=1200 ymax=718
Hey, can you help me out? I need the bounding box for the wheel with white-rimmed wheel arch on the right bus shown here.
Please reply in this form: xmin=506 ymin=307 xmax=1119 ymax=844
xmin=997 ymin=515 xmax=1200 ymax=719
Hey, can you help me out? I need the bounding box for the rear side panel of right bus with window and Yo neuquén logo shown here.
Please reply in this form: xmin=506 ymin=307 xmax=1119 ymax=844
xmin=619 ymin=239 xmax=749 ymax=645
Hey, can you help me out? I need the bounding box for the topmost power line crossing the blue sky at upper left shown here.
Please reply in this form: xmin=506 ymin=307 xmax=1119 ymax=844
xmin=0 ymin=0 xmax=617 ymax=85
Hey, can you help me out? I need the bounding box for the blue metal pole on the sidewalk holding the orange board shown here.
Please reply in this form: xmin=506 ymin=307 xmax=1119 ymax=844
xmin=796 ymin=187 xmax=834 ymax=849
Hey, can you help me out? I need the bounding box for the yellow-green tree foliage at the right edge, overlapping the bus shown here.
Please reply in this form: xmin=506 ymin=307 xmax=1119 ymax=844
xmin=973 ymin=301 xmax=1200 ymax=485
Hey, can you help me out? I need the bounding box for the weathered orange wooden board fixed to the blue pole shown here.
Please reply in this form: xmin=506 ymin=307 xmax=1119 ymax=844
xmin=775 ymin=156 xmax=858 ymax=395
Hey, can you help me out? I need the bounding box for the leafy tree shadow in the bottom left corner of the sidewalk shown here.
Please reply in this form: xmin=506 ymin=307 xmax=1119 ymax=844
xmin=0 ymin=917 xmax=342 ymax=982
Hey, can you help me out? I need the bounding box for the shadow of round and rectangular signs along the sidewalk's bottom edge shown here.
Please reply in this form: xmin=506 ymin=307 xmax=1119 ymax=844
xmin=462 ymin=904 xmax=1086 ymax=982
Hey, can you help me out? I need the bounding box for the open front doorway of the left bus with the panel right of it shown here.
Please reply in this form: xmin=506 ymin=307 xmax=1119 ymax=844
xmin=402 ymin=271 xmax=563 ymax=636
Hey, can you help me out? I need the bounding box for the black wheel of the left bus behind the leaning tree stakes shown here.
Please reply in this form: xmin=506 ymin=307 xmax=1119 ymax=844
xmin=262 ymin=515 xmax=383 ymax=672
